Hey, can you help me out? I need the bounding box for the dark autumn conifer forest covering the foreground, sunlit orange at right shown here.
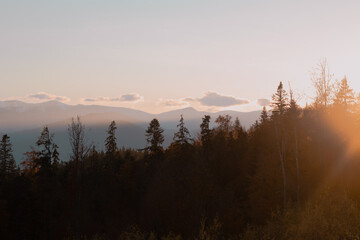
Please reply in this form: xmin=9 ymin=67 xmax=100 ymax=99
xmin=0 ymin=61 xmax=360 ymax=240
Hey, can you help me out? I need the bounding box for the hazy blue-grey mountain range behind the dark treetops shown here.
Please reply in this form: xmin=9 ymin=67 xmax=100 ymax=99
xmin=0 ymin=101 xmax=260 ymax=162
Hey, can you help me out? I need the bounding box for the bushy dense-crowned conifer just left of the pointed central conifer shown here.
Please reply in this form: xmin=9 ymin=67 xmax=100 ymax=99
xmin=145 ymin=118 xmax=164 ymax=153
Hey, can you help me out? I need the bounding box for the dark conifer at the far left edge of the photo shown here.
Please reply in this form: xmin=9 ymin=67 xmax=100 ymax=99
xmin=0 ymin=134 xmax=16 ymax=176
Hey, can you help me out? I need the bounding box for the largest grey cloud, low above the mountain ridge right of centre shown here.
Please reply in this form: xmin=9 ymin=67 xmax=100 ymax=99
xmin=197 ymin=92 xmax=249 ymax=107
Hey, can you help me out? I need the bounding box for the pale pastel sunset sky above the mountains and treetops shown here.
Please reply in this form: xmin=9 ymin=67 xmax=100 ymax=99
xmin=0 ymin=0 xmax=360 ymax=113
